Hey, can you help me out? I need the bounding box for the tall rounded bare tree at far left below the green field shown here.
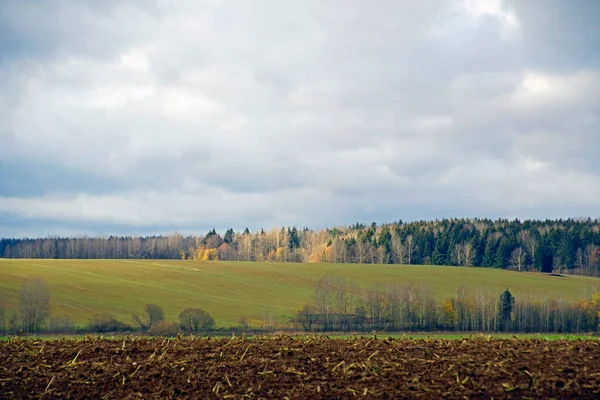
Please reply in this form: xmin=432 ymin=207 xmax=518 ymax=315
xmin=19 ymin=278 xmax=50 ymax=332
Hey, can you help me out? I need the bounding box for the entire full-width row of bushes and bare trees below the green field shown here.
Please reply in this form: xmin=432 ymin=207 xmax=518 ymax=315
xmin=0 ymin=276 xmax=600 ymax=336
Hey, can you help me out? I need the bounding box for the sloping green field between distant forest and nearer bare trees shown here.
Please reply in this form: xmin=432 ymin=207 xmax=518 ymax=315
xmin=0 ymin=259 xmax=600 ymax=326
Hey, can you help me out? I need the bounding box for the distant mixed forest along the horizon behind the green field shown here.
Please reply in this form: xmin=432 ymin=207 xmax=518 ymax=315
xmin=0 ymin=219 xmax=600 ymax=276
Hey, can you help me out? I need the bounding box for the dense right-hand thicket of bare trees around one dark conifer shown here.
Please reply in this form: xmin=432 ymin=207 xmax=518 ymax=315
xmin=290 ymin=276 xmax=600 ymax=333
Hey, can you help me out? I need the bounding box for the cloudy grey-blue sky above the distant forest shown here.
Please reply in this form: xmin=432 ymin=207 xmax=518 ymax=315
xmin=0 ymin=0 xmax=600 ymax=237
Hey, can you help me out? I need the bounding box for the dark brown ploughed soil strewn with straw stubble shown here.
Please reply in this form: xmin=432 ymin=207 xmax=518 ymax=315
xmin=0 ymin=337 xmax=600 ymax=400
